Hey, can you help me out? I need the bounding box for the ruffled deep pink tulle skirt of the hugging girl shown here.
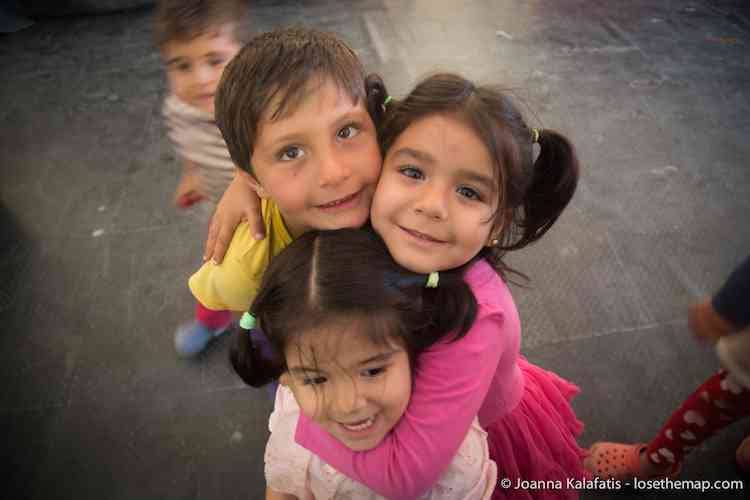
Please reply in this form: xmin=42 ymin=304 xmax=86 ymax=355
xmin=485 ymin=356 xmax=589 ymax=500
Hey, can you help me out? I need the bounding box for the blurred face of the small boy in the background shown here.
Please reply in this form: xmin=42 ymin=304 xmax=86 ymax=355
xmin=161 ymin=26 xmax=241 ymax=116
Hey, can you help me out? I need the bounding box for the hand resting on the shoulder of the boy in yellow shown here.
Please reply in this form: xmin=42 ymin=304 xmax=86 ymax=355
xmin=203 ymin=175 xmax=266 ymax=264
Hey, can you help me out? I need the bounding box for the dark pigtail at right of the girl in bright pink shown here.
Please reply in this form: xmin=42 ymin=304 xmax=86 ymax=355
xmin=504 ymin=130 xmax=580 ymax=250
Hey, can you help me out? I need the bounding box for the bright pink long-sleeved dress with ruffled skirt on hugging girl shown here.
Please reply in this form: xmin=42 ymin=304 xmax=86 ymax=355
xmin=296 ymin=260 xmax=587 ymax=500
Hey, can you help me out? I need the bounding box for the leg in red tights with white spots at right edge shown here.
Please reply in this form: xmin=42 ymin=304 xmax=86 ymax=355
xmin=646 ymin=370 xmax=750 ymax=466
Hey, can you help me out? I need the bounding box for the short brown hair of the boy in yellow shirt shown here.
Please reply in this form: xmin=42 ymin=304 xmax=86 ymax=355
xmin=215 ymin=28 xmax=367 ymax=174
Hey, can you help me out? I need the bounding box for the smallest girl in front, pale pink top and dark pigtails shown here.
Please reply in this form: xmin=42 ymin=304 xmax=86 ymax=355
xmin=231 ymin=229 xmax=497 ymax=500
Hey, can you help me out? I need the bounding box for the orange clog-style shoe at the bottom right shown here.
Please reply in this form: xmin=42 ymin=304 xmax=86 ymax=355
xmin=584 ymin=442 xmax=682 ymax=481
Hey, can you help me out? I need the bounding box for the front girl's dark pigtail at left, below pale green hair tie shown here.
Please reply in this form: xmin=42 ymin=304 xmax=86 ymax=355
xmin=229 ymin=325 xmax=283 ymax=387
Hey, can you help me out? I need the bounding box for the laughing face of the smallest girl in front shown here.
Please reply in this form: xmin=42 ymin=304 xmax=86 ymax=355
xmin=281 ymin=321 xmax=411 ymax=451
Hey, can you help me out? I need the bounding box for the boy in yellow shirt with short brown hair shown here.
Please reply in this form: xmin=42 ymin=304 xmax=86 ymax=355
xmin=175 ymin=28 xmax=385 ymax=357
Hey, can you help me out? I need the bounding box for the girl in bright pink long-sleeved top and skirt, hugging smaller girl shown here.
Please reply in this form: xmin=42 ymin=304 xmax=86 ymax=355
xmin=217 ymin=74 xmax=586 ymax=499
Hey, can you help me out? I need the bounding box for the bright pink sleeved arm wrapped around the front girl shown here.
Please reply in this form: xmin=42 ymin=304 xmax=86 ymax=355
xmin=295 ymin=312 xmax=503 ymax=499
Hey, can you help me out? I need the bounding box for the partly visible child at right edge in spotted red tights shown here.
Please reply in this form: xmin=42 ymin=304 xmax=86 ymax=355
xmin=586 ymin=256 xmax=750 ymax=480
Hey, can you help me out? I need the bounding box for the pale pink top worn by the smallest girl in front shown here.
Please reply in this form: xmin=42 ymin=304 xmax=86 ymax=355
xmin=265 ymin=386 xmax=497 ymax=500
